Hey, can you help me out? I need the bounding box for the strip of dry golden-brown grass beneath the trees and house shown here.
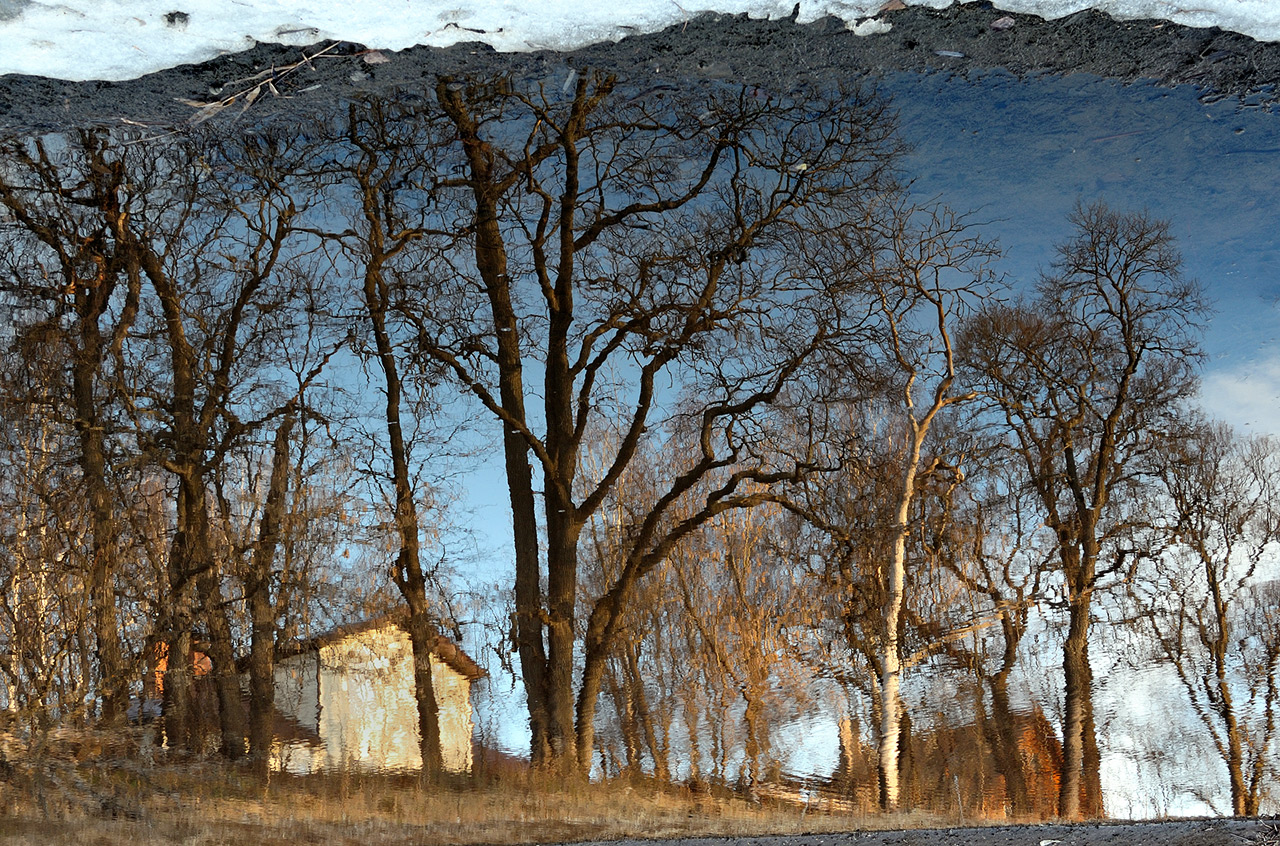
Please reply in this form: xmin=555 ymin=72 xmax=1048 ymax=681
xmin=0 ymin=763 xmax=977 ymax=846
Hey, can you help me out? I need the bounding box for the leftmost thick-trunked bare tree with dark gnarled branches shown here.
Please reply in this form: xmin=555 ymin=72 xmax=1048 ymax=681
xmin=0 ymin=131 xmax=138 ymax=726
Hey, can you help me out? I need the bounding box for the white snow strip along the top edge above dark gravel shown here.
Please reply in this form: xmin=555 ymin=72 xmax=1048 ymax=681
xmin=0 ymin=0 xmax=1280 ymax=81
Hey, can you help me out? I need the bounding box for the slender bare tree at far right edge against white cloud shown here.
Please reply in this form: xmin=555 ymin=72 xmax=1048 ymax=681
xmin=1130 ymin=422 xmax=1280 ymax=815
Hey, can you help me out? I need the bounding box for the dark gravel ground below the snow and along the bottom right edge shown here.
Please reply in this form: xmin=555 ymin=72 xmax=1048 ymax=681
xmin=0 ymin=3 xmax=1280 ymax=846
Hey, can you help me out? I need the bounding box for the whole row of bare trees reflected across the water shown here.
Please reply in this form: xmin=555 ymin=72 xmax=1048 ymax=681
xmin=0 ymin=73 xmax=1280 ymax=818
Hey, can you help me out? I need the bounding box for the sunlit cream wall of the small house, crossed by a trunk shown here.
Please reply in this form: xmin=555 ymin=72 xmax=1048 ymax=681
xmin=317 ymin=625 xmax=471 ymax=772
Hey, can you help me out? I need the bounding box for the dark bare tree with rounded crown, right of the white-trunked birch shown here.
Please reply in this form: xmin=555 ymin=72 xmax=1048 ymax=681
xmin=964 ymin=199 xmax=1206 ymax=819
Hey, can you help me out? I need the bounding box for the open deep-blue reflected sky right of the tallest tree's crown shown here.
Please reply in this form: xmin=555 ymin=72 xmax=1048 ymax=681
xmin=884 ymin=72 xmax=1280 ymax=433
